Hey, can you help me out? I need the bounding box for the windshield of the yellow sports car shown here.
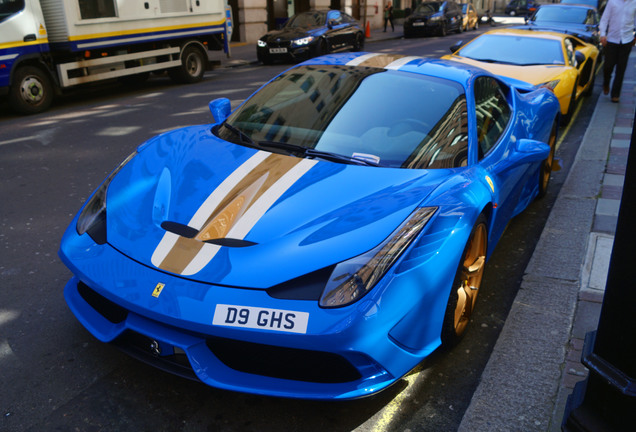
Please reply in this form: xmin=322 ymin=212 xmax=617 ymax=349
xmin=457 ymin=35 xmax=565 ymax=66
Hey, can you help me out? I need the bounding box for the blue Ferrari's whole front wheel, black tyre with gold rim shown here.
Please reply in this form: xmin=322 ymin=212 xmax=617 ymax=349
xmin=441 ymin=213 xmax=488 ymax=348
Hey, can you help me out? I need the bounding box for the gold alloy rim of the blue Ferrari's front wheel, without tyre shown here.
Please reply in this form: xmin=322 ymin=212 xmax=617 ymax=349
xmin=454 ymin=223 xmax=488 ymax=336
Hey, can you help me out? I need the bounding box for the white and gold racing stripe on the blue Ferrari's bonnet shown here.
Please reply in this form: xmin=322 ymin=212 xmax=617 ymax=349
xmin=151 ymin=151 xmax=316 ymax=275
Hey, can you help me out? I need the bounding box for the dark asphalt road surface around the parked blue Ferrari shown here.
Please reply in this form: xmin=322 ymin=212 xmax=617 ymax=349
xmin=0 ymin=29 xmax=599 ymax=432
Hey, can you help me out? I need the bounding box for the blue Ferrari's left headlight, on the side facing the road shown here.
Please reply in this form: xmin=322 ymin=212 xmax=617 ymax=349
xmin=75 ymin=152 xmax=137 ymax=244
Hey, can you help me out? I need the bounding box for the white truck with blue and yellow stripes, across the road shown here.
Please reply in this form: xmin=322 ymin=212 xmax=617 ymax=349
xmin=0 ymin=0 xmax=231 ymax=114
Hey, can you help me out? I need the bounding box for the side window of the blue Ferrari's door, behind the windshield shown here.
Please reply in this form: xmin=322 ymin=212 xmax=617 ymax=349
xmin=475 ymin=77 xmax=510 ymax=159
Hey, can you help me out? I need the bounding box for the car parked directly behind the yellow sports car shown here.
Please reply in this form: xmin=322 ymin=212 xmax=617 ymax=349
xmin=513 ymin=4 xmax=601 ymax=49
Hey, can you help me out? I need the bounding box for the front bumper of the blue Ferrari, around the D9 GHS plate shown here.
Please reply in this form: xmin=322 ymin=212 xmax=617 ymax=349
xmin=59 ymin=206 xmax=470 ymax=399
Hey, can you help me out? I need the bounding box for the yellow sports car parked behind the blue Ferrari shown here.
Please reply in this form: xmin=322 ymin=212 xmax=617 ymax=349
xmin=443 ymin=29 xmax=598 ymax=124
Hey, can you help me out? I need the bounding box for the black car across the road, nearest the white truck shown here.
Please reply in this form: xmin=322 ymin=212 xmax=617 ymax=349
xmin=256 ymin=10 xmax=364 ymax=64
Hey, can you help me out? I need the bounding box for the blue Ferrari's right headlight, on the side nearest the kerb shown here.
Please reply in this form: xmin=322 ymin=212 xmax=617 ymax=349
xmin=320 ymin=207 xmax=437 ymax=308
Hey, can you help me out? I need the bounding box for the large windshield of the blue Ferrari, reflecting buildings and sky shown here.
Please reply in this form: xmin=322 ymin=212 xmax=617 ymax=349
xmin=217 ymin=65 xmax=468 ymax=168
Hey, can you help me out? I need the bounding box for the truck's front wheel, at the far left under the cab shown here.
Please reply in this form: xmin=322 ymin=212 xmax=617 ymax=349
xmin=8 ymin=66 xmax=53 ymax=114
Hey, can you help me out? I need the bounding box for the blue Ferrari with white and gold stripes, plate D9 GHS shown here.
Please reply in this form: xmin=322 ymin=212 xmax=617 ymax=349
xmin=60 ymin=53 xmax=559 ymax=399
